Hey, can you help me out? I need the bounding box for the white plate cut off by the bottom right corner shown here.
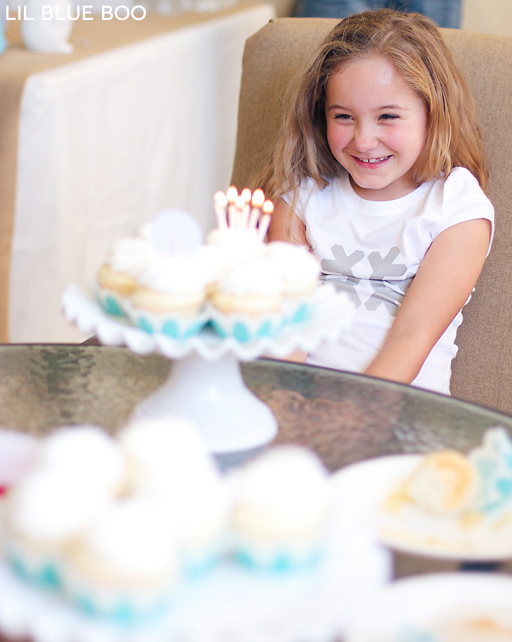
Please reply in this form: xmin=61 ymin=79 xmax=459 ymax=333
xmin=345 ymin=573 xmax=512 ymax=642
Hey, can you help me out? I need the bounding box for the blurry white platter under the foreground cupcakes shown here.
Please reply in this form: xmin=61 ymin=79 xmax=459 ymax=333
xmin=0 ymin=492 xmax=392 ymax=642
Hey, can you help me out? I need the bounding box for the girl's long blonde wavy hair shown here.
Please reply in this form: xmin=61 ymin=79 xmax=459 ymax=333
xmin=256 ymin=9 xmax=488 ymax=209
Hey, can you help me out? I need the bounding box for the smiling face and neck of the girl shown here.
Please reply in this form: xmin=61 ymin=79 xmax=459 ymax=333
xmin=325 ymin=56 xmax=427 ymax=201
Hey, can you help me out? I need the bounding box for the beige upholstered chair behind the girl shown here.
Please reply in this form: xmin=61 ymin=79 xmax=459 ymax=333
xmin=232 ymin=18 xmax=512 ymax=414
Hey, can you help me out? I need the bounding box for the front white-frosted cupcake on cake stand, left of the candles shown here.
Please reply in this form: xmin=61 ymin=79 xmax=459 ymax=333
xmin=128 ymin=256 xmax=207 ymax=339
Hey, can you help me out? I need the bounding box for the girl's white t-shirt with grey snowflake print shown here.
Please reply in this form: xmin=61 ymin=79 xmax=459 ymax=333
xmin=285 ymin=167 xmax=494 ymax=394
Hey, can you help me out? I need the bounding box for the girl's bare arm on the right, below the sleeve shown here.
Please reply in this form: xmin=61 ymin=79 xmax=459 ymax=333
xmin=365 ymin=219 xmax=491 ymax=383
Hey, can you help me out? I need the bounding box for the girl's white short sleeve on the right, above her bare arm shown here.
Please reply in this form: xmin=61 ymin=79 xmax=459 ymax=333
xmin=435 ymin=167 xmax=494 ymax=254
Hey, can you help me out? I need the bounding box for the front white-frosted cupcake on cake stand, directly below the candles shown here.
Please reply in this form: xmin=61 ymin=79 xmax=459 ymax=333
xmin=210 ymin=259 xmax=284 ymax=342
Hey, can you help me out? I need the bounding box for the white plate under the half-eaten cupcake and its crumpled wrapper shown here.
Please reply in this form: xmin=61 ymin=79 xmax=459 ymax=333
xmin=333 ymin=455 xmax=512 ymax=561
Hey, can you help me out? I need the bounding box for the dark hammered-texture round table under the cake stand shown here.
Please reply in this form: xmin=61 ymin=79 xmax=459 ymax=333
xmin=0 ymin=344 xmax=512 ymax=577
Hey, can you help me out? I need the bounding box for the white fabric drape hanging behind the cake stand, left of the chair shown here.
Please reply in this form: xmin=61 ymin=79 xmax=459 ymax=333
xmin=9 ymin=4 xmax=274 ymax=342
